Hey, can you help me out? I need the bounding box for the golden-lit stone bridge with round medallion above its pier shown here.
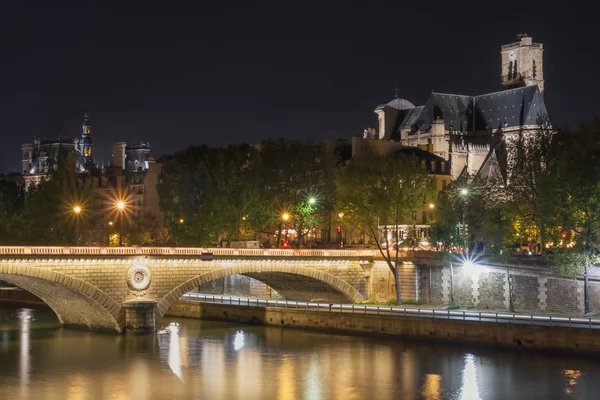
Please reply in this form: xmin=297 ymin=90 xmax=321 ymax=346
xmin=0 ymin=247 xmax=418 ymax=333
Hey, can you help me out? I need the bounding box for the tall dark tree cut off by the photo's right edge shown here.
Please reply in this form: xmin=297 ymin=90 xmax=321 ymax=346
xmin=538 ymin=119 xmax=600 ymax=314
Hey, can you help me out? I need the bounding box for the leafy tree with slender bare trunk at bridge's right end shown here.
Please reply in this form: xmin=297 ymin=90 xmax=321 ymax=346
xmin=336 ymin=154 xmax=435 ymax=304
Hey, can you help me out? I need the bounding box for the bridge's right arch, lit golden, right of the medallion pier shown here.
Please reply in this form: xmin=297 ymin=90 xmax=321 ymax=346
xmin=157 ymin=263 xmax=365 ymax=318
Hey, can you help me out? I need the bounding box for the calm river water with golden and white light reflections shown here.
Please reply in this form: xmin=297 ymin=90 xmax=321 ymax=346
xmin=0 ymin=306 xmax=600 ymax=400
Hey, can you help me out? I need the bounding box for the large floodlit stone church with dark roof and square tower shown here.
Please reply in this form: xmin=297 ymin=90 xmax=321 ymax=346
xmin=352 ymin=34 xmax=549 ymax=180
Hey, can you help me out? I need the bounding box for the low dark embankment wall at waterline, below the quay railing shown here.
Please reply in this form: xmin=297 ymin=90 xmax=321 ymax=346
xmin=167 ymin=300 xmax=600 ymax=354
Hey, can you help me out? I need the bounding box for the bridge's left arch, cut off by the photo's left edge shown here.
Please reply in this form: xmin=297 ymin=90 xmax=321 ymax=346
xmin=0 ymin=263 xmax=125 ymax=333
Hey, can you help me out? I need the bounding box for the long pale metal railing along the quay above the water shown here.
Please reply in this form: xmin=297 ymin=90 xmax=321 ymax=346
xmin=183 ymin=293 xmax=600 ymax=329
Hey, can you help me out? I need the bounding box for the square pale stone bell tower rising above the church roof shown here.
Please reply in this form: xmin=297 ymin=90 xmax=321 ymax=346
xmin=501 ymin=33 xmax=544 ymax=95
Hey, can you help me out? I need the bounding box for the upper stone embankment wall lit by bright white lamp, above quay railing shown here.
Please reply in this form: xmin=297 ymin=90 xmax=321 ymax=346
xmin=419 ymin=265 xmax=600 ymax=315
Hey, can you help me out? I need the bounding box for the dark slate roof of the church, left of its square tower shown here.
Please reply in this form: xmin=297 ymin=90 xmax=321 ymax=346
xmin=400 ymin=86 xmax=548 ymax=132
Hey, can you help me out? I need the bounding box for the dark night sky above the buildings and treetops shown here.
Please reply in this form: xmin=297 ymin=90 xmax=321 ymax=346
xmin=0 ymin=0 xmax=600 ymax=171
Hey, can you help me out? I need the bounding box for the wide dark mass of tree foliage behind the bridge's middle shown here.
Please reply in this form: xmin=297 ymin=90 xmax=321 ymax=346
xmin=158 ymin=139 xmax=336 ymax=246
